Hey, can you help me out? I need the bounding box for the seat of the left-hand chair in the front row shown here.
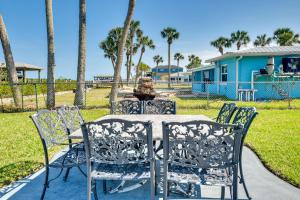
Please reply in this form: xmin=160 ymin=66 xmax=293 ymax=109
xmin=91 ymin=163 xmax=150 ymax=180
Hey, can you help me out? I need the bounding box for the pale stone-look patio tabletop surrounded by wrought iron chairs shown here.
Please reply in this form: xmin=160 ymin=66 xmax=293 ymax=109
xmin=69 ymin=114 xmax=212 ymax=141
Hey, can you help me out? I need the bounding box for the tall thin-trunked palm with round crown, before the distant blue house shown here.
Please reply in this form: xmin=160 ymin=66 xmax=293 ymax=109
xmin=161 ymin=27 xmax=179 ymax=88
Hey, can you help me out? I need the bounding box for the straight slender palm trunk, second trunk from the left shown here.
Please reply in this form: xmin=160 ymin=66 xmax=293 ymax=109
xmin=45 ymin=0 xmax=55 ymax=109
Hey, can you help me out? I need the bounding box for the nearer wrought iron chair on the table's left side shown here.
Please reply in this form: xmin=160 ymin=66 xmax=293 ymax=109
xmin=30 ymin=110 xmax=86 ymax=199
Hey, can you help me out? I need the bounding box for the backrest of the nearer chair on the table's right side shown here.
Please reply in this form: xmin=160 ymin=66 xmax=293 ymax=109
xmin=232 ymin=107 xmax=258 ymax=137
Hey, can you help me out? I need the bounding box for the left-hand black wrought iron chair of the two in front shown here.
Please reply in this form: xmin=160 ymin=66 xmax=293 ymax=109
xmin=82 ymin=119 xmax=155 ymax=200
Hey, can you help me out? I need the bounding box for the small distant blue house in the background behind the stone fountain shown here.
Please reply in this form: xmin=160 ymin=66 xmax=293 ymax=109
xmin=151 ymin=65 xmax=183 ymax=80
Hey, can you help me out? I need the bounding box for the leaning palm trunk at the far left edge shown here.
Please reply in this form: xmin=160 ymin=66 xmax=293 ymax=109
xmin=0 ymin=15 xmax=22 ymax=108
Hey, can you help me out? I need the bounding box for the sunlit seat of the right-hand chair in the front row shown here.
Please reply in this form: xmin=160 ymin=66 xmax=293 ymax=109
xmin=168 ymin=166 xmax=232 ymax=186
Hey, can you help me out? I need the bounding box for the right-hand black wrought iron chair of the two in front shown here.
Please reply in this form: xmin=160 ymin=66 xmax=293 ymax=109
xmin=163 ymin=121 xmax=242 ymax=200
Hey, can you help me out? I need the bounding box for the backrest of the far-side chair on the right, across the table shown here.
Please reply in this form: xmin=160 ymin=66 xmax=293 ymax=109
xmin=143 ymin=99 xmax=176 ymax=115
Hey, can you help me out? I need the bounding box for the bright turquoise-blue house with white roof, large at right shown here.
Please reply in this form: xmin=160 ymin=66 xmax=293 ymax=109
xmin=192 ymin=46 xmax=300 ymax=101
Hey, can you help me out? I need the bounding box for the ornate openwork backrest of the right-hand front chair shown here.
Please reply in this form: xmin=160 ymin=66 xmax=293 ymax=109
xmin=163 ymin=121 xmax=242 ymax=169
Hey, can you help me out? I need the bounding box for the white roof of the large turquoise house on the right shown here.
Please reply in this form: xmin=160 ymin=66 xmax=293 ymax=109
xmin=206 ymin=46 xmax=300 ymax=62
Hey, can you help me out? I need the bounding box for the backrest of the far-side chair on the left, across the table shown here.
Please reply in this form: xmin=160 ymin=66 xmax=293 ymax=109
xmin=110 ymin=99 xmax=142 ymax=115
